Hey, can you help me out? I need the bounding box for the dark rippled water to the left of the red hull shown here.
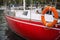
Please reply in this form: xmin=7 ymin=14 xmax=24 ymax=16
xmin=0 ymin=10 xmax=25 ymax=40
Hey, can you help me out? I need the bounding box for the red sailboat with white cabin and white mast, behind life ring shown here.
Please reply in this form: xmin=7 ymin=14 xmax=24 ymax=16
xmin=5 ymin=0 xmax=60 ymax=40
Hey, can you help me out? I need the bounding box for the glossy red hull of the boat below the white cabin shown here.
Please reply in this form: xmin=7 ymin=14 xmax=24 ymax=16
xmin=6 ymin=16 xmax=60 ymax=40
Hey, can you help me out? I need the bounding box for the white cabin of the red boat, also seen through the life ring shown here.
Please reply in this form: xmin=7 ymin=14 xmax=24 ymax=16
xmin=11 ymin=9 xmax=60 ymax=23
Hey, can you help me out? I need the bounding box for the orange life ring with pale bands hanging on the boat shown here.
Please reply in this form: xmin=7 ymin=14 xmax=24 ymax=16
xmin=41 ymin=6 xmax=58 ymax=27
